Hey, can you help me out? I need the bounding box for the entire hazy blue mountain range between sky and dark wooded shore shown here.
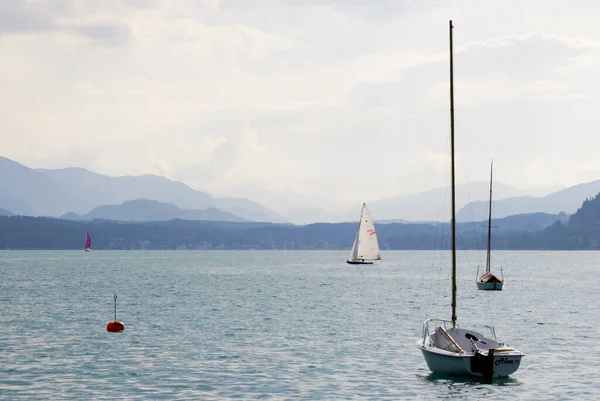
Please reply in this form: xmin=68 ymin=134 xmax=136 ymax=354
xmin=0 ymin=157 xmax=600 ymax=224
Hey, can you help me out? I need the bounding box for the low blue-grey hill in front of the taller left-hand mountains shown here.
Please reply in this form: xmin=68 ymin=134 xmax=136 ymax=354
xmin=74 ymin=199 xmax=247 ymax=222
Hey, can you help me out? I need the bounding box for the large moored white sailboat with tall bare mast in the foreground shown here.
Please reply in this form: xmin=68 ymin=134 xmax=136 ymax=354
xmin=415 ymin=21 xmax=523 ymax=379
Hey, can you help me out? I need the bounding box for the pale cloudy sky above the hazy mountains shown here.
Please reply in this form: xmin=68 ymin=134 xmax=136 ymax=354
xmin=0 ymin=0 xmax=600 ymax=212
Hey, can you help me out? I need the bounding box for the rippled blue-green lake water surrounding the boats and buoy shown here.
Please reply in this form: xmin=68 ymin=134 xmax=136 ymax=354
xmin=0 ymin=251 xmax=600 ymax=400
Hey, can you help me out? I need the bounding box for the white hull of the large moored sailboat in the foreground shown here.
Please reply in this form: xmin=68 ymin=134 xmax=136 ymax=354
xmin=416 ymin=340 xmax=523 ymax=378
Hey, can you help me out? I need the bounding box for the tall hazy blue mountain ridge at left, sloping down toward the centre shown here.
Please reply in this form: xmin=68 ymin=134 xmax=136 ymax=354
xmin=0 ymin=156 xmax=287 ymax=223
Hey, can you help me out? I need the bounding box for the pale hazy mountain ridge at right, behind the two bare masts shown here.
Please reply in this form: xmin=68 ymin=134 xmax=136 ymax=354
xmin=456 ymin=180 xmax=600 ymax=221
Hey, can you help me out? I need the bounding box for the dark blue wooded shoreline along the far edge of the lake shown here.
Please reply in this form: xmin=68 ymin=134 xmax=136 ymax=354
xmin=0 ymin=208 xmax=600 ymax=250
